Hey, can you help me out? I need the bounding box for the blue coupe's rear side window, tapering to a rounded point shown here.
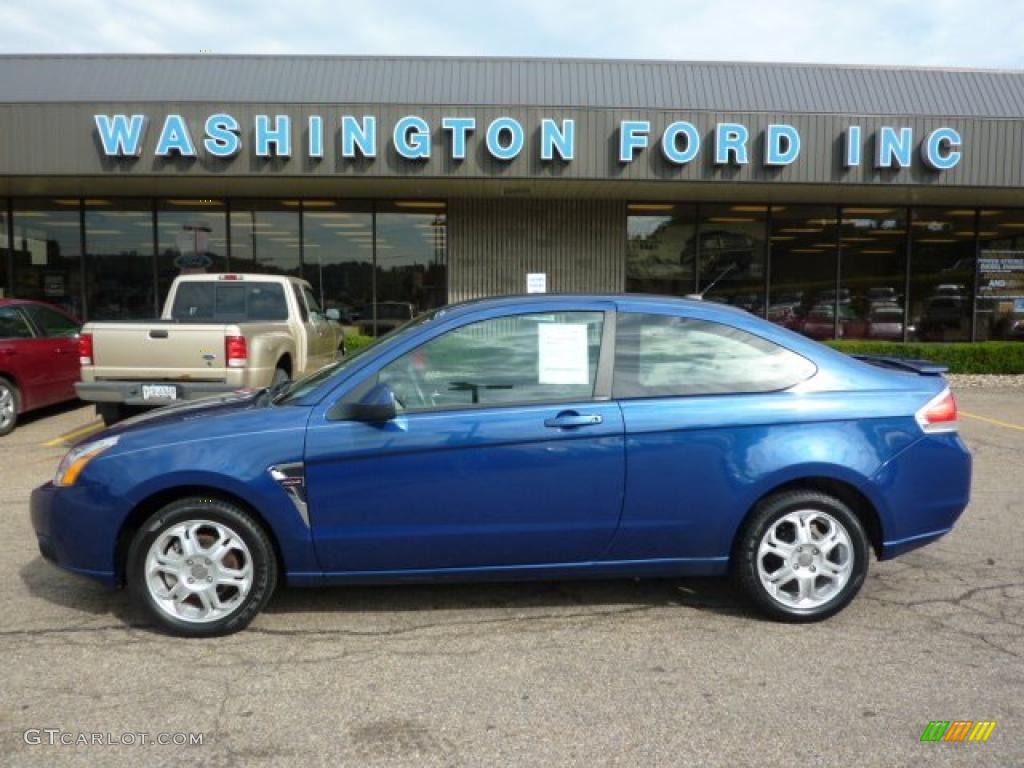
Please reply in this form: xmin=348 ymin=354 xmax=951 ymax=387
xmin=612 ymin=312 xmax=817 ymax=398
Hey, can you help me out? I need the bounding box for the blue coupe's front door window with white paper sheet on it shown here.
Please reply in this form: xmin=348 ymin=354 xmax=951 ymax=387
xmin=378 ymin=312 xmax=604 ymax=411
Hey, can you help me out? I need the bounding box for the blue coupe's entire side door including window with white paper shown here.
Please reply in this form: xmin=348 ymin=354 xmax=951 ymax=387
xmin=306 ymin=305 xmax=625 ymax=573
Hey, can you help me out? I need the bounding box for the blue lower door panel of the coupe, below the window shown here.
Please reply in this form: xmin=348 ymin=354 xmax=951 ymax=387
xmin=306 ymin=402 xmax=626 ymax=572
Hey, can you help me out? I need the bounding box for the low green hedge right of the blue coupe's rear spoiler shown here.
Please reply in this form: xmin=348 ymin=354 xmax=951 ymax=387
xmin=825 ymin=341 xmax=1024 ymax=374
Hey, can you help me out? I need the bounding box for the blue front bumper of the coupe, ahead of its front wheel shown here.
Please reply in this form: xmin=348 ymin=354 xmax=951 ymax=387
xmin=30 ymin=482 xmax=117 ymax=585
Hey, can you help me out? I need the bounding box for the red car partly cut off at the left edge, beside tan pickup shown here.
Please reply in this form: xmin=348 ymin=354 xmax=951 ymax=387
xmin=0 ymin=299 xmax=82 ymax=437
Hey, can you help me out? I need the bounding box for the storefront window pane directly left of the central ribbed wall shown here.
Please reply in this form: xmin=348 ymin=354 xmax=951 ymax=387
xmin=370 ymin=201 xmax=447 ymax=334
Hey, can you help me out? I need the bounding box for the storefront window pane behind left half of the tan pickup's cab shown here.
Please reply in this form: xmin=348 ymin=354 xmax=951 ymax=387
xmin=157 ymin=198 xmax=227 ymax=306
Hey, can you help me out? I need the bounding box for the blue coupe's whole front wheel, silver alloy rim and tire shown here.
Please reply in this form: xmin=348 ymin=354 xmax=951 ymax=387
xmin=127 ymin=497 xmax=278 ymax=637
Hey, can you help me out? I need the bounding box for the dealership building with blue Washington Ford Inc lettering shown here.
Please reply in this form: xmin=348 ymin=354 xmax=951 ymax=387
xmin=0 ymin=55 xmax=1024 ymax=341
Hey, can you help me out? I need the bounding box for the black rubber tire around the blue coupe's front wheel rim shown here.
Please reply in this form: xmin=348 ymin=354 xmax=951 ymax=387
xmin=126 ymin=497 xmax=278 ymax=637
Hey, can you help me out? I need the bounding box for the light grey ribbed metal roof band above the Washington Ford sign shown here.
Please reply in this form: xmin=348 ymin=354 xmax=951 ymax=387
xmin=6 ymin=55 xmax=1024 ymax=118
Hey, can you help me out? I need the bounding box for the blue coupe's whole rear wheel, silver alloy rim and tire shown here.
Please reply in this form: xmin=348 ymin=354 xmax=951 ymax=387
xmin=734 ymin=490 xmax=869 ymax=622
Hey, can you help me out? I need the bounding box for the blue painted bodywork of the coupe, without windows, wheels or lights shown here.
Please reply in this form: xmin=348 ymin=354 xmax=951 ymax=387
xmin=32 ymin=296 xmax=971 ymax=585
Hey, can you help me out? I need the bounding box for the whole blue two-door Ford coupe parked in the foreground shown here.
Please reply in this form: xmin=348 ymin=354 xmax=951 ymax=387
xmin=32 ymin=295 xmax=971 ymax=636
